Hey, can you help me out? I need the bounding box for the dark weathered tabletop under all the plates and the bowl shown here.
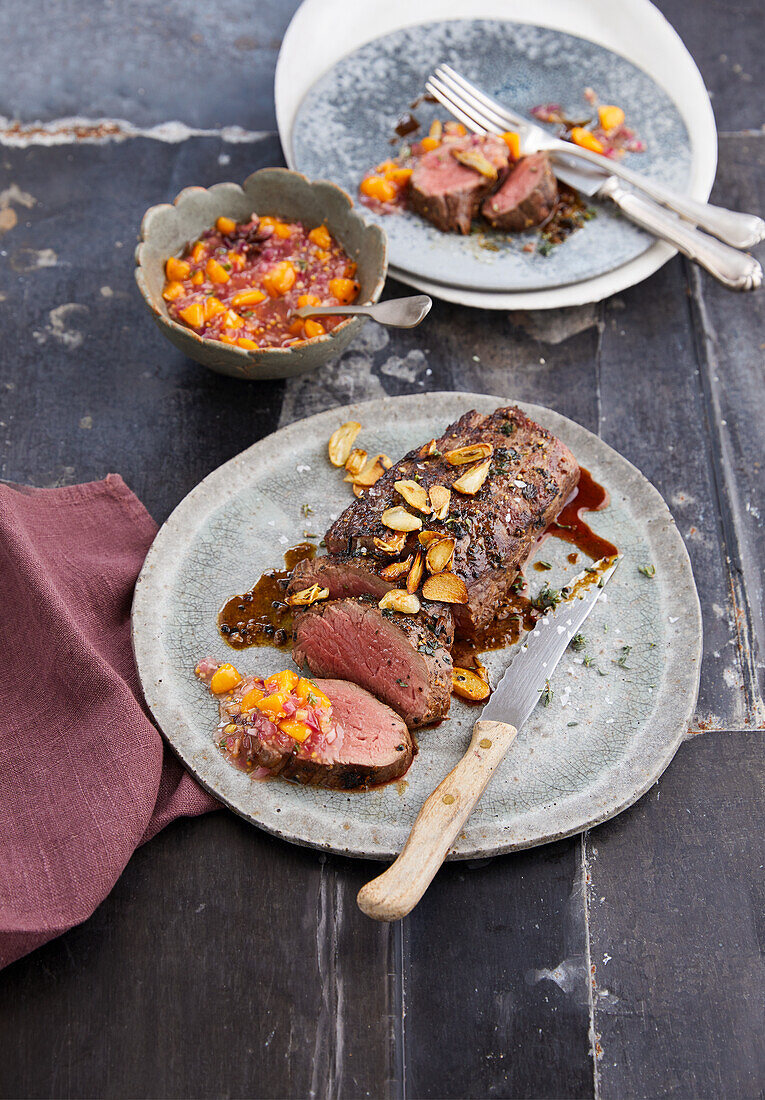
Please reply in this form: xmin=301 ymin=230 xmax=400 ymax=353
xmin=0 ymin=0 xmax=765 ymax=1098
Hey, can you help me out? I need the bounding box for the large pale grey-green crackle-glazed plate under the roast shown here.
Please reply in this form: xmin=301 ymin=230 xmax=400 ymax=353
xmin=133 ymin=394 xmax=701 ymax=858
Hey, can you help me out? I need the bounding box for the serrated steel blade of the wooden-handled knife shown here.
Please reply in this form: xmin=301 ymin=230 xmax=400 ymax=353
xmin=480 ymin=558 xmax=620 ymax=729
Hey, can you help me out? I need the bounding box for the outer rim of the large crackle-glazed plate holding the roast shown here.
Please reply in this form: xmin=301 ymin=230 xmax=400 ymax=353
xmin=131 ymin=391 xmax=703 ymax=859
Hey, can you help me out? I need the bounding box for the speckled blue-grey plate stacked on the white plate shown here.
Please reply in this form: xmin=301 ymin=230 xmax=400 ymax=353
xmin=292 ymin=20 xmax=691 ymax=292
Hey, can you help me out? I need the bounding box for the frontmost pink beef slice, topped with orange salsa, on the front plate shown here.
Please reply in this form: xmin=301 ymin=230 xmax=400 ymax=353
xmin=197 ymin=658 xmax=416 ymax=790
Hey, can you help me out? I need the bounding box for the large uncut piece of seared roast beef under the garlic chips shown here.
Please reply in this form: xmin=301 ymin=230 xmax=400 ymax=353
xmin=326 ymin=406 xmax=579 ymax=637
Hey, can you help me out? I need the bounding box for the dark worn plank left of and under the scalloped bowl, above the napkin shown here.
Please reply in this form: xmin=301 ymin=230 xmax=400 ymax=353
xmin=0 ymin=139 xmax=283 ymax=520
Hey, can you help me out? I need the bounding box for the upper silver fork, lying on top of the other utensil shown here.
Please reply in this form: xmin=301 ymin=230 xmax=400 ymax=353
xmin=434 ymin=65 xmax=765 ymax=249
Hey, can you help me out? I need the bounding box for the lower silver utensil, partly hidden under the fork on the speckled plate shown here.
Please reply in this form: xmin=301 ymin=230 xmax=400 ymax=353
xmin=426 ymin=69 xmax=763 ymax=290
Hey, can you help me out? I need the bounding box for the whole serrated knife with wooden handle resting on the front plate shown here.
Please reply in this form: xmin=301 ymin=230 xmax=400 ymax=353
xmin=357 ymin=558 xmax=619 ymax=921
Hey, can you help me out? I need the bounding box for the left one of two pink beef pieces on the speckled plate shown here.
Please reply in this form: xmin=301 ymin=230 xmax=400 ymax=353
xmin=407 ymin=134 xmax=509 ymax=233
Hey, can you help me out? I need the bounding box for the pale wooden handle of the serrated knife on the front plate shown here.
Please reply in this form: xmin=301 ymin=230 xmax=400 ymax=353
xmin=357 ymin=722 xmax=517 ymax=921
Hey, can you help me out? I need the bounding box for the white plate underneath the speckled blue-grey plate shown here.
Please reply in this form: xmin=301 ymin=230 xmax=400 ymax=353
xmin=275 ymin=0 xmax=717 ymax=309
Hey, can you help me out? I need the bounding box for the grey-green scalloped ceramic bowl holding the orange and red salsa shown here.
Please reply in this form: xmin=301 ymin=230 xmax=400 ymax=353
xmin=135 ymin=168 xmax=387 ymax=380
